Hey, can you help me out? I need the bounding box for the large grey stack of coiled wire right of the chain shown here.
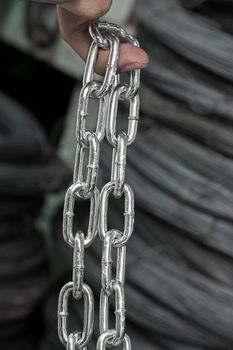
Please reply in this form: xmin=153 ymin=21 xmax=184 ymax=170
xmin=43 ymin=0 xmax=233 ymax=350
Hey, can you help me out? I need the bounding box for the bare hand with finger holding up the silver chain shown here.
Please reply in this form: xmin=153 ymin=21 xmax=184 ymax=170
xmin=33 ymin=0 xmax=148 ymax=74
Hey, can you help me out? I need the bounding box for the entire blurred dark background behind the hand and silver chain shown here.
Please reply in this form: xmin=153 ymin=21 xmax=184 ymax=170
xmin=0 ymin=0 xmax=233 ymax=350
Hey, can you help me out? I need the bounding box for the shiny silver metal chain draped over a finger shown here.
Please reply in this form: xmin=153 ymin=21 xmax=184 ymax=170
xmin=58 ymin=22 xmax=140 ymax=350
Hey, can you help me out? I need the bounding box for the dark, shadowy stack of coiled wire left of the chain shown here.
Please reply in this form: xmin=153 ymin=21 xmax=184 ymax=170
xmin=0 ymin=94 xmax=70 ymax=350
